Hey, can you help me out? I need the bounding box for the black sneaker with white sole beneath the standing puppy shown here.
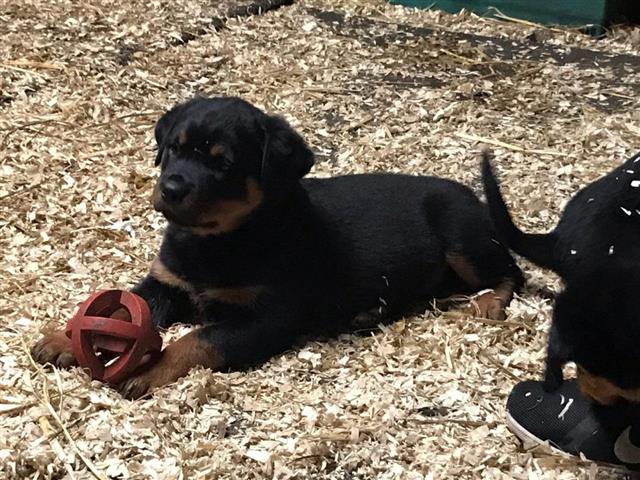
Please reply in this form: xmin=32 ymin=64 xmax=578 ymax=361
xmin=507 ymin=380 xmax=640 ymax=470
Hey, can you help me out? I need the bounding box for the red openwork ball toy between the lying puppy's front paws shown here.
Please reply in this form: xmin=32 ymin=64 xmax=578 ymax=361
xmin=65 ymin=290 xmax=162 ymax=383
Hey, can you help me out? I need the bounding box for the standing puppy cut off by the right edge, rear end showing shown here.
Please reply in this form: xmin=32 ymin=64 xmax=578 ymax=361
xmin=482 ymin=151 xmax=640 ymax=404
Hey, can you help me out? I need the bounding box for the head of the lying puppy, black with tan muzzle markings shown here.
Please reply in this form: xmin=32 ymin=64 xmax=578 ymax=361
xmin=153 ymin=97 xmax=314 ymax=235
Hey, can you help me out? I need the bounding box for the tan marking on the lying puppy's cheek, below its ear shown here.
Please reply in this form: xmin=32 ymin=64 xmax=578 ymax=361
xmin=190 ymin=178 xmax=264 ymax=235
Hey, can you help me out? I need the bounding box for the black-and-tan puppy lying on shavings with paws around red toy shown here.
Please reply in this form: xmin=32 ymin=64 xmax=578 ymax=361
xmin=33 ymin=98 xmax=523 ymax=398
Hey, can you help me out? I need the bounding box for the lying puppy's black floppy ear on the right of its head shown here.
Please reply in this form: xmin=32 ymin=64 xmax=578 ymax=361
xmin=262 ymin=116 xmax=315 ymax=181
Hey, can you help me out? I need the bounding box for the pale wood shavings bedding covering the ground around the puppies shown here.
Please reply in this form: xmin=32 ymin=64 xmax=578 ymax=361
xmin=0 ymin=0 xmax=640 ymax=480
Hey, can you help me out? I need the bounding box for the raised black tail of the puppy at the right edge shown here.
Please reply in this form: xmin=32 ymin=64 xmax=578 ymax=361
xmin=482 ymin=149 xmax=558 ymax=270
